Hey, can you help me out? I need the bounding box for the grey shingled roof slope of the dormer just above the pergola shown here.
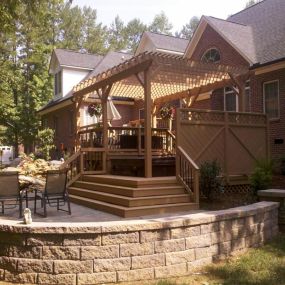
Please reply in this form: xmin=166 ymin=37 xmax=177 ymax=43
xmin=141 ymin=32 xmax=189 ymax=54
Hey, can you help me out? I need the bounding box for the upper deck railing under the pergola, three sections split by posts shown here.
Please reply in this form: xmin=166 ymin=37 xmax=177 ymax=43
xmin=79 ymin=125 xmax=175 ymax=155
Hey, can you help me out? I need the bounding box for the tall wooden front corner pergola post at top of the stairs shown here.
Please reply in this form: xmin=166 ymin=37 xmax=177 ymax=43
xmin=144 ymin=69 xmax=152 ymax=178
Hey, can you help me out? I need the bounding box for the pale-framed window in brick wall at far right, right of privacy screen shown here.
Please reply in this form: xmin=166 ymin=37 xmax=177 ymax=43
xmin=263 ymin=80 xmax=279 ymax=119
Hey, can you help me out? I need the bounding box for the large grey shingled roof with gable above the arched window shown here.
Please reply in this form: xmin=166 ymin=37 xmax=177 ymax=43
xmin=185 ymin=0 xmax=285 ymax=65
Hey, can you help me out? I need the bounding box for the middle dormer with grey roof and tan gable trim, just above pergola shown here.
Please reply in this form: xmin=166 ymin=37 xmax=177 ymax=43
xmin=136 ymin=32 xmax=189 ymax=55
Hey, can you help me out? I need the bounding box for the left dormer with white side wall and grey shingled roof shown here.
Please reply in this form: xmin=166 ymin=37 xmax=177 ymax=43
xmin=49 ymin=49 xmax=102 ymax=99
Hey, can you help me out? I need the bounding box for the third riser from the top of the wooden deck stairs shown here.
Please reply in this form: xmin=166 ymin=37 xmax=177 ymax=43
xmin=69 ymin=188 xmax=190 ymax=207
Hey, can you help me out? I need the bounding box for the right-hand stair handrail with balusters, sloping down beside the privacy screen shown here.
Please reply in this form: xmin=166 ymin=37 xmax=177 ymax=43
xmin=176 ymin=146 xmax=200 ymax=203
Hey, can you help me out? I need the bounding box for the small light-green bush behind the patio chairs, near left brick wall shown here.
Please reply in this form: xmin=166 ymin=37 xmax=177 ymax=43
xmin=37 ymin=128 xmax=55 ymax=160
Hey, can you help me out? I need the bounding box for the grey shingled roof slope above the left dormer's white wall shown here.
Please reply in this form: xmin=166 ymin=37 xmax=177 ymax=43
xmin=54 ymin=49 xmax=103 ymax=70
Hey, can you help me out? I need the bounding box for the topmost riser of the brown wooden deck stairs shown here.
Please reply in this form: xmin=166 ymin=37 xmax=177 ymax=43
xmin=82 ymin=175 xmax=177 ymax=188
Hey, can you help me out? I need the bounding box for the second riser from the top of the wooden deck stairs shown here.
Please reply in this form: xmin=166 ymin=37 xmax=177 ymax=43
xmin=73 ymin=181 xmax=185 ymax=197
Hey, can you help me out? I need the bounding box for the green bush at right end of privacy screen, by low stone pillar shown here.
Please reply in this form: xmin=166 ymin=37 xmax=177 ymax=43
xmin=249 ymin=160 xmax=273 ymax=194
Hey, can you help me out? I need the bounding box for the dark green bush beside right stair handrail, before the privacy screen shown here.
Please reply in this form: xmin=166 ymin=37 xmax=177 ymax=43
xmin=200 ymin=160 xmax=222 ymax=200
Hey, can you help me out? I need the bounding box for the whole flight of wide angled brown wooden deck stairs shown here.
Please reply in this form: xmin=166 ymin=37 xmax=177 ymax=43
xmin=68 ymin=175 xmax=198 ymax=218
